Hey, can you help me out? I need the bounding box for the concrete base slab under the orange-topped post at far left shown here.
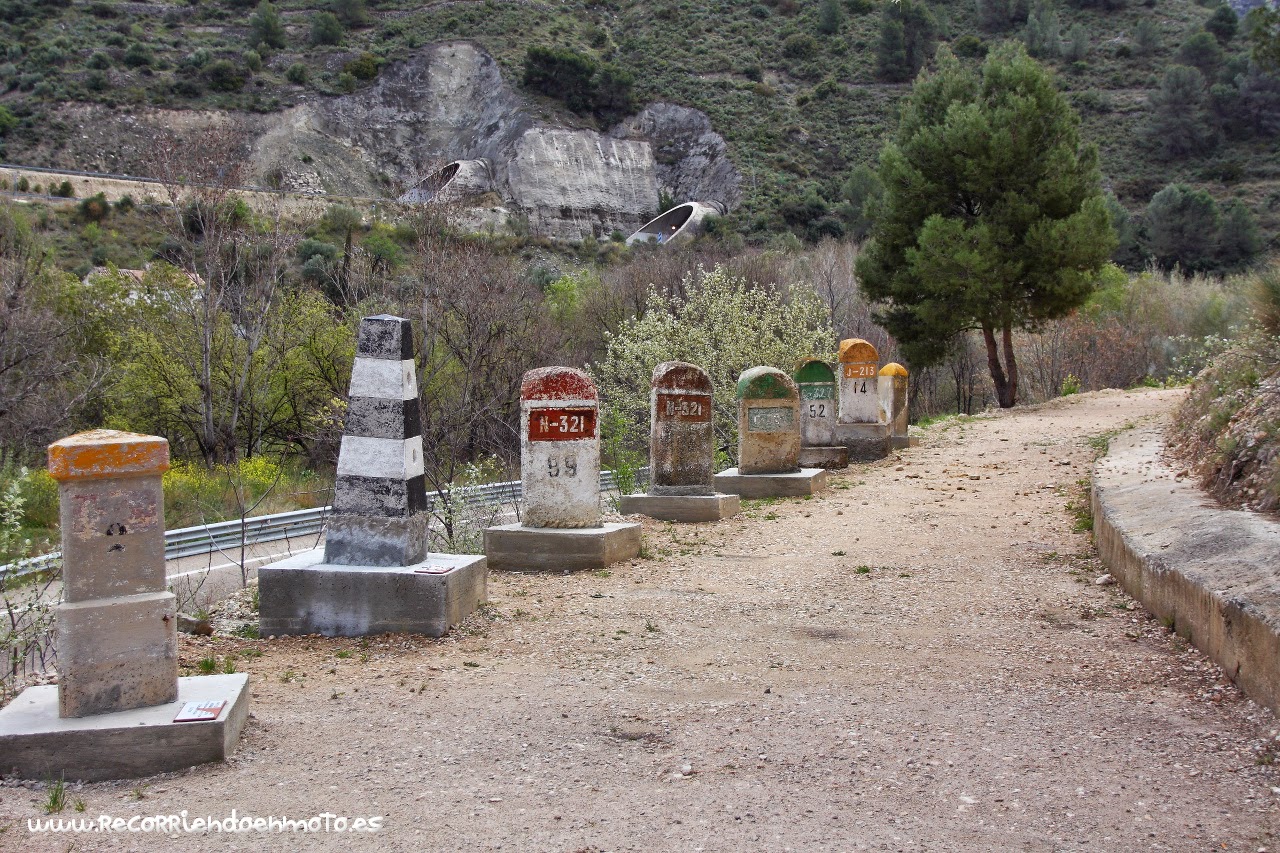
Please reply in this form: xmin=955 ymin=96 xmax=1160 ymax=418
xmin=0 ymin=672 xmax=248 ymax=781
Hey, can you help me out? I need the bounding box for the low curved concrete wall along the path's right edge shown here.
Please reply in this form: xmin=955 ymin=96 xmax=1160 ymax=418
xmin=1093 ymin=428 xmax=1280 ymax=712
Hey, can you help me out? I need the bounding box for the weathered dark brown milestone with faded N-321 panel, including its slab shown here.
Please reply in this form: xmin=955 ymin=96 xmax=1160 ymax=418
xmin=620 ymin=361 xmax=741 ymax=521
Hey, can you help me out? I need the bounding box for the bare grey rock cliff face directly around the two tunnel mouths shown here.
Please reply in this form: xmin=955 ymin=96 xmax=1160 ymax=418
xmin=314 ymin=42 xmax=740 ymax=240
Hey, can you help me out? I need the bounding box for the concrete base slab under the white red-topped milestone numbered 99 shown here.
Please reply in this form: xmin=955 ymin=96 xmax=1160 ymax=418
xmin=484 ymin=523 xmax=640 ymax=571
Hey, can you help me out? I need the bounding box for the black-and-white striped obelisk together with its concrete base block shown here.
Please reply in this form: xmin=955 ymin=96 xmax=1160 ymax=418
xmin=259 ymin=314 xmax=488 ymax=637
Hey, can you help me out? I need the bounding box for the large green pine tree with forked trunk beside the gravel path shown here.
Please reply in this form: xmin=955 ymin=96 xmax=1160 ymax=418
xmin=858 ymin=44 xmax=1115 ymax=407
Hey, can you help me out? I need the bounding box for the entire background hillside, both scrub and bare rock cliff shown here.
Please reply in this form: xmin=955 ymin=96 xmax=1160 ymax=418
xmin=0 ymin=0 xmax=1280 ymax=249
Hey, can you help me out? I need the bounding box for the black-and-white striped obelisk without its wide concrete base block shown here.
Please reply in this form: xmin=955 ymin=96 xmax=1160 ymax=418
xmin=324 ymin=314 xmax=428 ymax=566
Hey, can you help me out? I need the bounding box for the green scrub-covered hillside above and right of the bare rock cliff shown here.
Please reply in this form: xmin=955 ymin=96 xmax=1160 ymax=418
xmin=0 ymin=0 xmax=1280 ymax=256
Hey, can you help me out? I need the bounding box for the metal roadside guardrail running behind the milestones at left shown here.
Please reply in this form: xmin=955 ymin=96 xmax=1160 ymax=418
xmin=0 ymin=467 xmax=649 ymax=581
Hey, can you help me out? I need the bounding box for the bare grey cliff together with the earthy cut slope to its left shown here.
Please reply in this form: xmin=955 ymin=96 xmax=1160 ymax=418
xmin=37 ymin=42 xmax=741 ymax=240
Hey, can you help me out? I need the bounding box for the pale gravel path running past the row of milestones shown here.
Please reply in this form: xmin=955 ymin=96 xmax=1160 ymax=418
xmin=0 ymin=391 xmax=1280 ymax=852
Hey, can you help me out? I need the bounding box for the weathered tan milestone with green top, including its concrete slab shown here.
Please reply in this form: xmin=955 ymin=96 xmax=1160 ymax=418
xmin=716 ymin=366 xmax=827 ymax=498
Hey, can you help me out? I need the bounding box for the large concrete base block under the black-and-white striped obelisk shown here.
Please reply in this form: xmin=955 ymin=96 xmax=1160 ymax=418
xmin=257 ymin=548 xmax=488 ymax=637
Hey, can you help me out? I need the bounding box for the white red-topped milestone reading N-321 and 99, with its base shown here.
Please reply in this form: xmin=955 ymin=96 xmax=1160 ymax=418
xmin=484 ymin=368 xmax=640 ymax=571
